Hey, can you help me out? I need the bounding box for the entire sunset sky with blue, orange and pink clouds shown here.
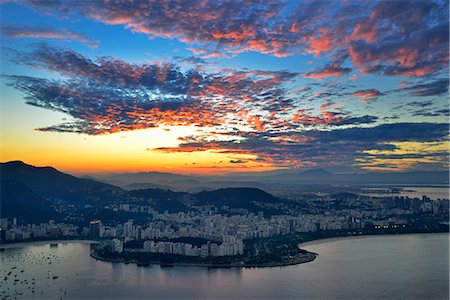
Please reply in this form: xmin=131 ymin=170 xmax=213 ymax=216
xmin=0 ymin=0 xmax=449 ymax=175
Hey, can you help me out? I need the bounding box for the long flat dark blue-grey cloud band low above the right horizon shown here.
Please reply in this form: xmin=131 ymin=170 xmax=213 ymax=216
xmin=154 ymin=123 xmax=449 ymax=167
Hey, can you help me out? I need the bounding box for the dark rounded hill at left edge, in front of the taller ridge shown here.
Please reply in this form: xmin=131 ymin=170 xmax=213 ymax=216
xmin=0 ymin=180 xmax=58 ymax=224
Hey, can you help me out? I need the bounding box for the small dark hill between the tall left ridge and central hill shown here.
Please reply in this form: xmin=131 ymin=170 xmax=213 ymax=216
xmin=126 ymin=189 xmax=189 ymax=213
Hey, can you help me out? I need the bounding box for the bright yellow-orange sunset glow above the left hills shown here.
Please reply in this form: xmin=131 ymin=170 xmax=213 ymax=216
xmin=0 ymin=119 xmax=276 ymax=174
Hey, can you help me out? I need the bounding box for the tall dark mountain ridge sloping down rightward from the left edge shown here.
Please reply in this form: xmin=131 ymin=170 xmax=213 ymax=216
xmin=0 ymin=161 xmax=124 ymax=204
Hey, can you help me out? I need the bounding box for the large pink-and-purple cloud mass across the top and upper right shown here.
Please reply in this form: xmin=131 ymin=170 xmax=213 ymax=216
xmin=15 ymin=0 xmax=449 ymax=78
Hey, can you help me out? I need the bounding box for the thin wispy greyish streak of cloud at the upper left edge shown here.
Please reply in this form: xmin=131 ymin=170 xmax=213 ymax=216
xmin=0 ymin=24 xmax=98 ymax=48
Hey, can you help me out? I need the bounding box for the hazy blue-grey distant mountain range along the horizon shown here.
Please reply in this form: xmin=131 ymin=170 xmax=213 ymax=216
xmin=101 ymin=169 xmax=449 ymax=192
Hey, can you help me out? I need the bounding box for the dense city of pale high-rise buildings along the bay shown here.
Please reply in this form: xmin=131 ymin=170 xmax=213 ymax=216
xmin=0 ymin=188 xmax=449 ymax=264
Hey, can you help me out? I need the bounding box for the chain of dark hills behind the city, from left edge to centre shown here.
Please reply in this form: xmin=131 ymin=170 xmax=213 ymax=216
xmin=0 ymin=161 xmax=281 ymax=224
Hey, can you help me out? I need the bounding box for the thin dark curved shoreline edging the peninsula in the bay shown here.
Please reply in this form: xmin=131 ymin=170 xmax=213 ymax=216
xmin=90 ymin=251 xmax=318 ymax=268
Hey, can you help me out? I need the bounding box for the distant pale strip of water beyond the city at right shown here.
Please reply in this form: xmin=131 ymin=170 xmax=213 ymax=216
xmin=364 ymin=185 xmax=450 ymax=200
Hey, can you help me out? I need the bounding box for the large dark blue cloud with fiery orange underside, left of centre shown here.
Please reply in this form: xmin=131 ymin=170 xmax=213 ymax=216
xmin=7 ymin=44 xmax=312 ymax=134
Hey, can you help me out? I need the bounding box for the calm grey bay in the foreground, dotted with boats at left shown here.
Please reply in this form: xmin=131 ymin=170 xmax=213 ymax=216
xmin=0 ymin=234 xmax=449 ymax=299
